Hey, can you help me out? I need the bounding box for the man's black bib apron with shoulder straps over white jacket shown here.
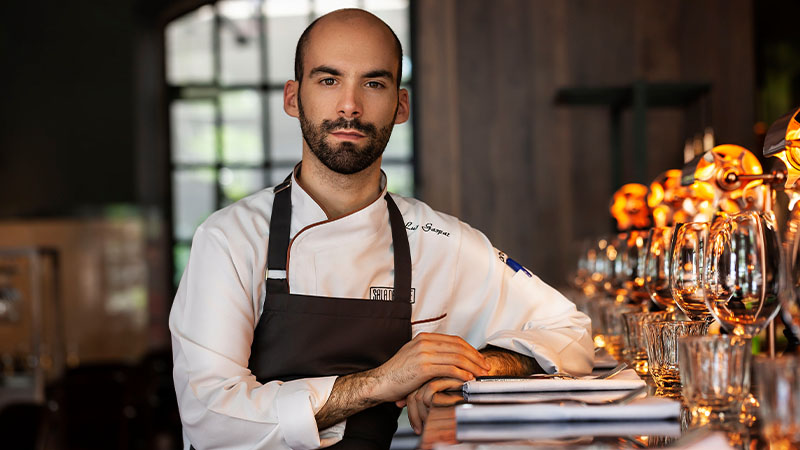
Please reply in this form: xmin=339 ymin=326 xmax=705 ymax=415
xmin=249 ymin=178 xmax=411 ymax=449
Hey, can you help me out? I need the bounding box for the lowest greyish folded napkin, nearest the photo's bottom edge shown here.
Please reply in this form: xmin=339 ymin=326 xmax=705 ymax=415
xmin=456 ymin=420 xmax=681 ymax=441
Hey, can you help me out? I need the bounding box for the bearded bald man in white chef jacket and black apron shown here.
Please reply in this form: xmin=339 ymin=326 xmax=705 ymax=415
xmin=170 ymin=10 xmax=592 ymax=449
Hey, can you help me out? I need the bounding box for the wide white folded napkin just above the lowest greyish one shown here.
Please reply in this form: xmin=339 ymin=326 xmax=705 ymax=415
xmin=456 ymin=397 xmax=681 ymax=424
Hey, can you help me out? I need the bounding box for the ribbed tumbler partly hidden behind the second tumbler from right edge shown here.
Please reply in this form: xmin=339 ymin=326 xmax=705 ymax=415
xmin=642 ymin=320 xmax=709 ymax=391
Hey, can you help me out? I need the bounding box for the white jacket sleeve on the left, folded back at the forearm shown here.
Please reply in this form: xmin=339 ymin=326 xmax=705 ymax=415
xmin=169 ymin=226 xmax=344 ymax=450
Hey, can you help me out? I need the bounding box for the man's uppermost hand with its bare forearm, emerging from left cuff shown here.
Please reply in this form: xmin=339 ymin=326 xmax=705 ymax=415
xmin=315 ymin=333 xmax=491 ymax=430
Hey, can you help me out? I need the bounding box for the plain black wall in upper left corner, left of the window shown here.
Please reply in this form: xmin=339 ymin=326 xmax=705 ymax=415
xmin=0 ymin=0 xmax=136 ymax=217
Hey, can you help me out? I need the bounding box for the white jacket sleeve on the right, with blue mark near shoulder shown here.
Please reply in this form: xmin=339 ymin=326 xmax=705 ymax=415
xmin=445 ymin=224 xmax=594 ymax=375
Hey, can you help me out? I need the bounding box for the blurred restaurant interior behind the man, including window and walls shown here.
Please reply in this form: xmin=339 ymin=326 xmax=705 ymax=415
xmin=0 ymin=0 xmax=800 ymax=449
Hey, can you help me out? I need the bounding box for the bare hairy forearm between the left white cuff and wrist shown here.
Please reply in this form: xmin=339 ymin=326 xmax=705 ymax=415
xmin=314 ymin=370 xmax=381 ymax=430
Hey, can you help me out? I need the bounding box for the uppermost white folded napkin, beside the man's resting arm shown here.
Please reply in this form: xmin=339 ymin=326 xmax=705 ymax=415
xmin=462 ymin=369 xmax=645 ymax=395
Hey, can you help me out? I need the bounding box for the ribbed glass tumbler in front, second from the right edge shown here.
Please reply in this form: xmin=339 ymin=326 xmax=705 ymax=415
xmin=678 ymin=335 xmax=752 ymax=425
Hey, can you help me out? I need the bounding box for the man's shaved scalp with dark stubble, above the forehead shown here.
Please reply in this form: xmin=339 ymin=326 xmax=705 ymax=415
xmin=294 ymin=9 xmax=403 ymax=84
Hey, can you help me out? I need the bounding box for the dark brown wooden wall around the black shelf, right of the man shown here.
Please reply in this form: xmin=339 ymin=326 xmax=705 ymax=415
xmin=414 ymin=0 xmax=754 ymax=284
